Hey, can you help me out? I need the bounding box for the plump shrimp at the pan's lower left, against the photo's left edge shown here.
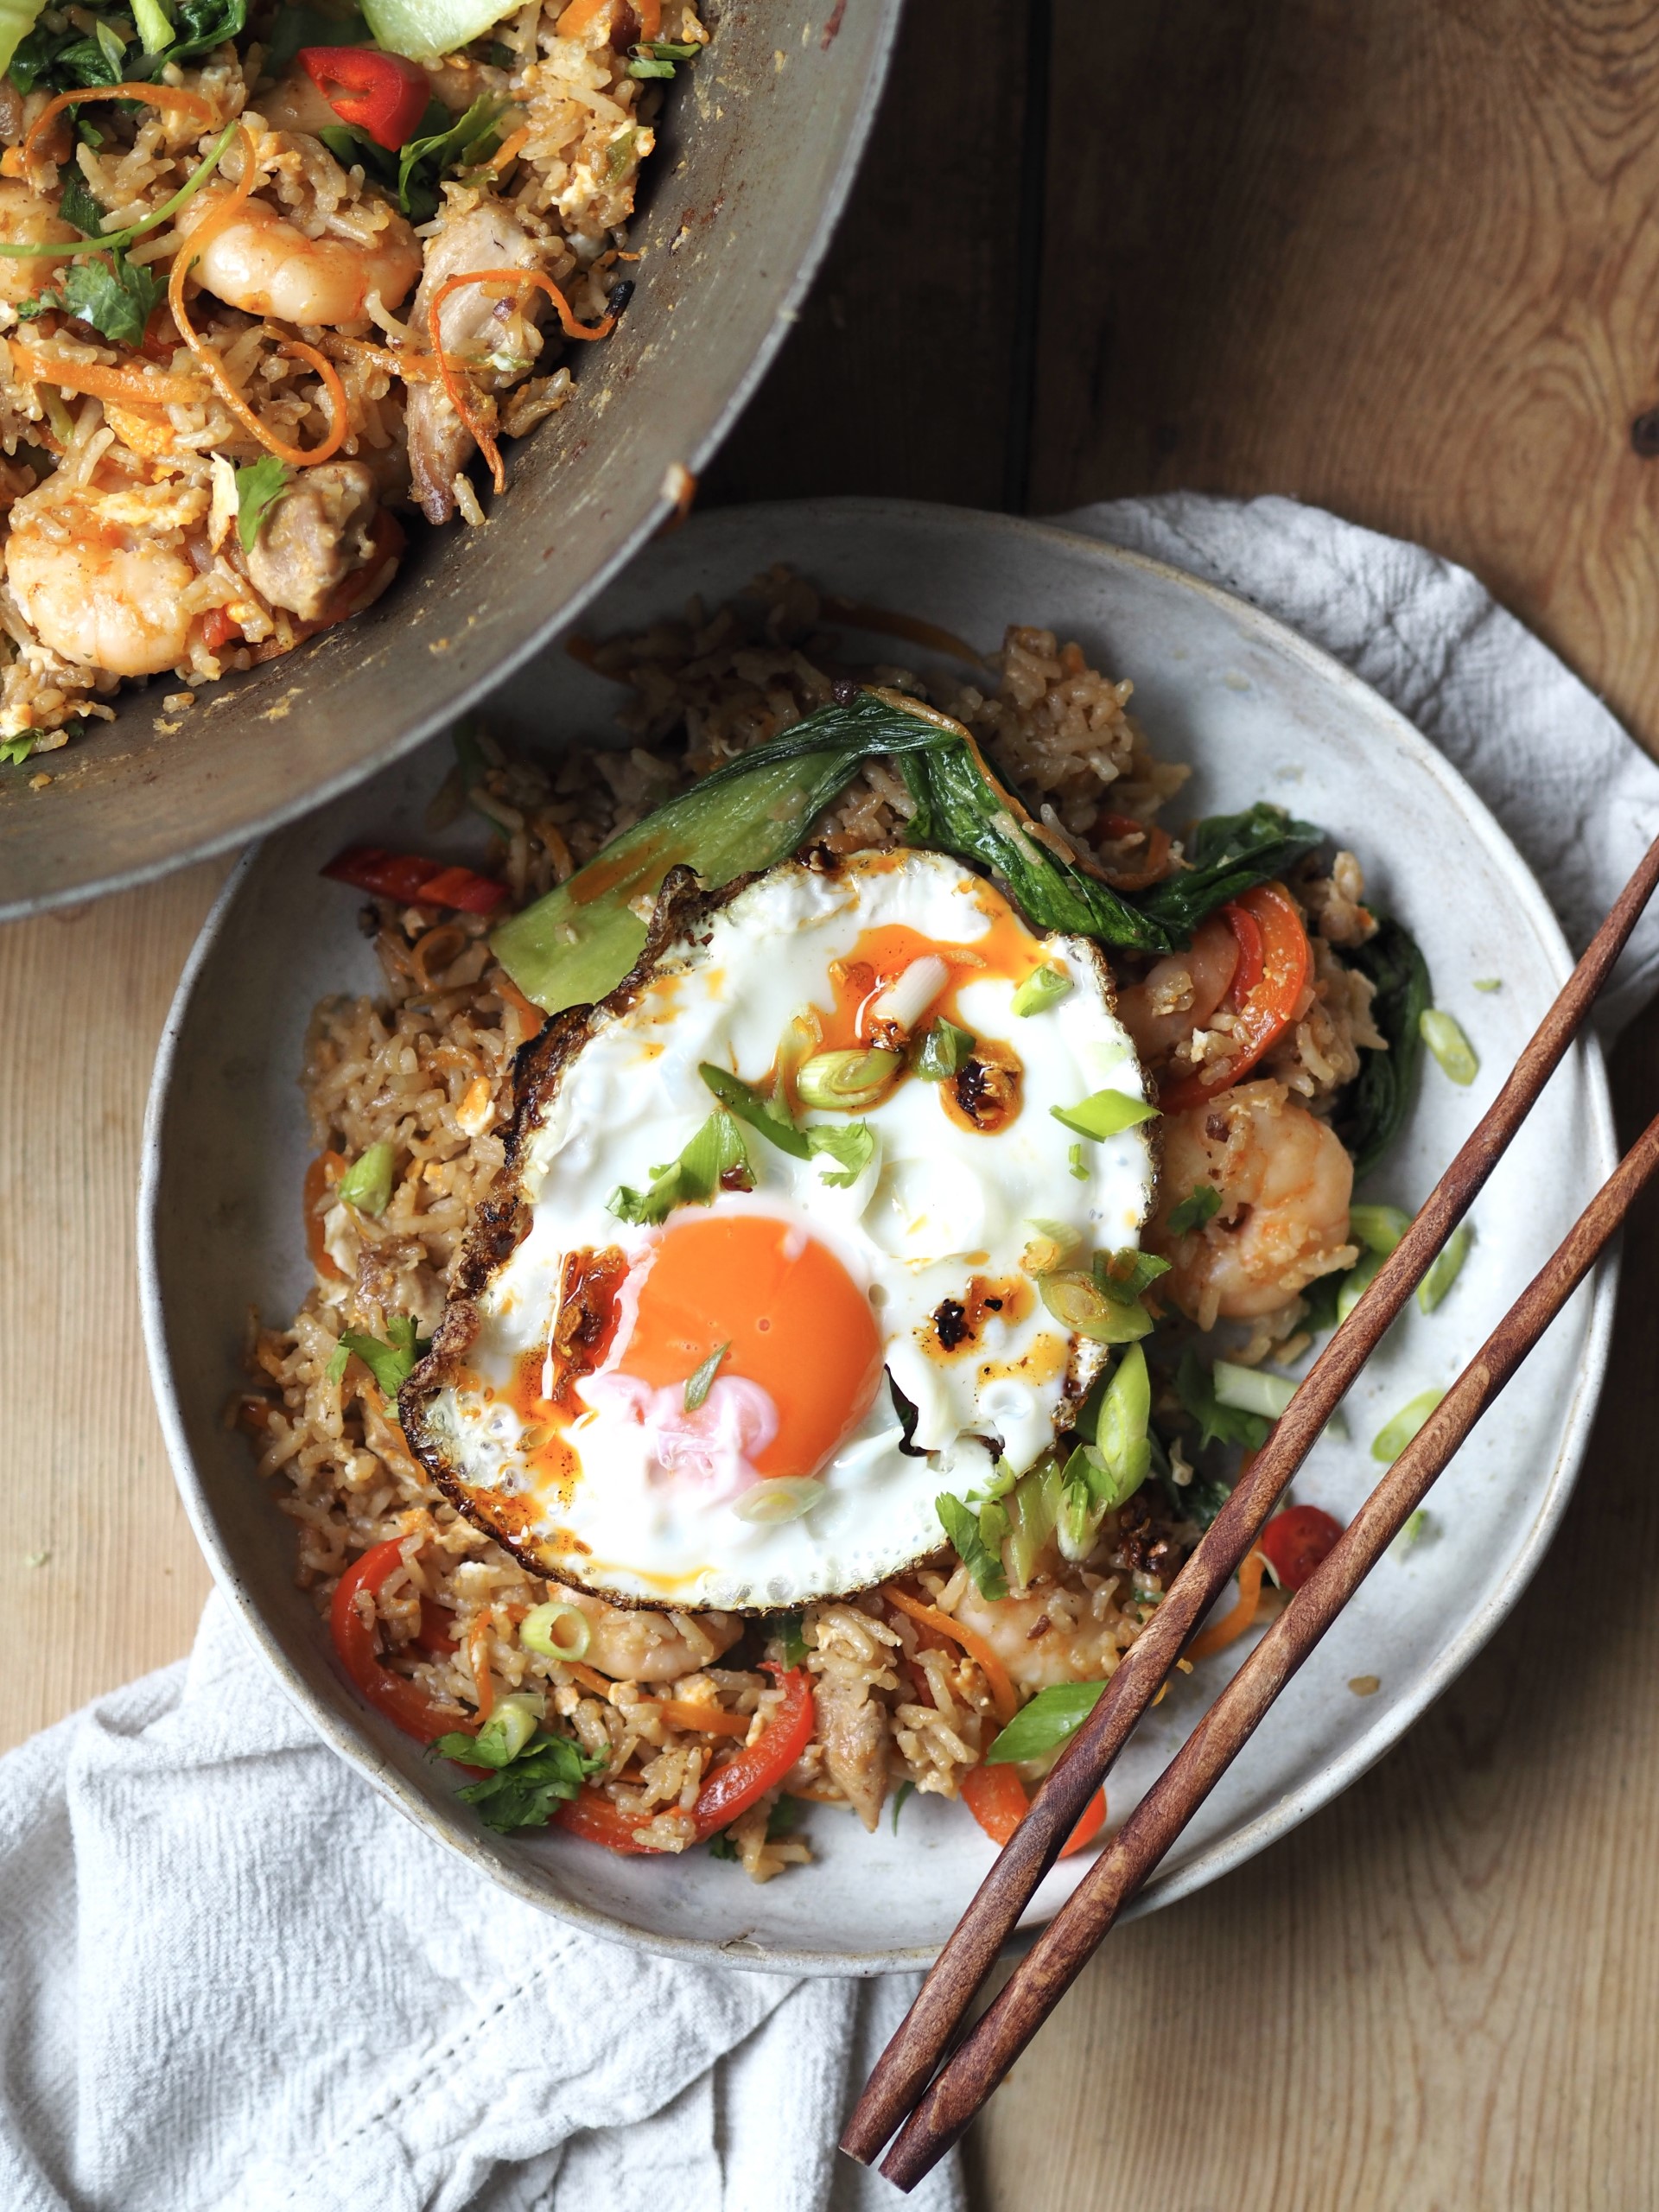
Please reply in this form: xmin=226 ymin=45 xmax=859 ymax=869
xmin=4 ymin=486 xmax=206 ymax=677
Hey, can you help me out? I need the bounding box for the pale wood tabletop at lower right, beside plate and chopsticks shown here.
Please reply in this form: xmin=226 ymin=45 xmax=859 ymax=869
xmin=971 ymin=1008 xmax=1659 ymax=2212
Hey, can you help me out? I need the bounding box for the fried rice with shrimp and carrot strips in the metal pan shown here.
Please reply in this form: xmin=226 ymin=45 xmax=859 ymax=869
xmin=0 ymin=0 xmax=708 ymax=763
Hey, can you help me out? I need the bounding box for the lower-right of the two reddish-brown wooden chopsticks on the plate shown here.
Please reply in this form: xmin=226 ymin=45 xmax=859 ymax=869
xmin=880 ymin=1117 xmax=1659 ymax=2190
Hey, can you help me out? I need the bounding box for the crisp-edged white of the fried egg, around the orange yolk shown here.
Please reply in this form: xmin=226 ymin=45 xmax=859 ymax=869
xmin=423 ymin=852 xmax=1154 ymax=1611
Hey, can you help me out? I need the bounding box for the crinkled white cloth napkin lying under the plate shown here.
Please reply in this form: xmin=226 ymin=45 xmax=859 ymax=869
xmin=0 ymin=495 xmax=1659 ymax=2212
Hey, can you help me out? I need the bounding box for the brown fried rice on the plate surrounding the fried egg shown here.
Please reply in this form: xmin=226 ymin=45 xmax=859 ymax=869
xmin=232 ymin=570 xmax=1374 ymax=1880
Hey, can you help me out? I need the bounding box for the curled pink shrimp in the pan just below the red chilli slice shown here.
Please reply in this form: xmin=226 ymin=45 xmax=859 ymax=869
xmin=179 ymin=193 xmax=420 ymax=327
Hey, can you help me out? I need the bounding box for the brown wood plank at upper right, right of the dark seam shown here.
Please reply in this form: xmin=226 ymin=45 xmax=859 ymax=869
xmin=1033 ymin=0 xmax=1659 ymax=743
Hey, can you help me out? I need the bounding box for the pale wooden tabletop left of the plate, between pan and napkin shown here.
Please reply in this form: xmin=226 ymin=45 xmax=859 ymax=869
xmin=0 ymin=861 xmax=228 ymax=1747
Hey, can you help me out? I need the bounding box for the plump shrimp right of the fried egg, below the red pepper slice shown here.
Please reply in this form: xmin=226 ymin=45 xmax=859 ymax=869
xmin=1144 ymin=1082 xmax=1358 ymax=1330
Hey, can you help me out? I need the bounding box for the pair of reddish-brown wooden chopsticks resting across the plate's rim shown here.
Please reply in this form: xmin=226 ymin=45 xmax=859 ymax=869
xmin=841 ymin=841 xmax=1659 ymax=2190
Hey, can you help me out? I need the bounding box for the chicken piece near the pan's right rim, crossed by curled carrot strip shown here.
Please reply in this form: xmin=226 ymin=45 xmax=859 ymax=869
xmin=407 ymin=199 xmax=549 ymax=522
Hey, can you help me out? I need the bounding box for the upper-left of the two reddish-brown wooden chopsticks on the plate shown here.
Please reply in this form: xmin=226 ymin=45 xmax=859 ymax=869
xmin=841 ymin=841 xmax=1659 ymax=2164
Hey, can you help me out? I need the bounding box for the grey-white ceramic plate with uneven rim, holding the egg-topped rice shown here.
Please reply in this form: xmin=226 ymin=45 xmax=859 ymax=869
xmin=142 ymin=500 xmax=1615 ymax=1974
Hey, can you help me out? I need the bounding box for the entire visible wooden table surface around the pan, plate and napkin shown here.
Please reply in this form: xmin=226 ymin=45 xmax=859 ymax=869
xmin=0 ymin=0 xmax=1659 ymax=2212
